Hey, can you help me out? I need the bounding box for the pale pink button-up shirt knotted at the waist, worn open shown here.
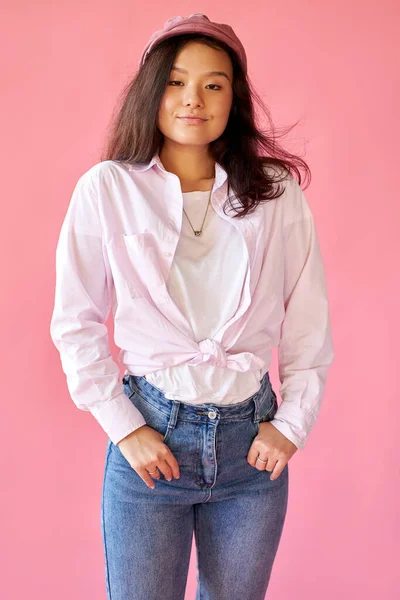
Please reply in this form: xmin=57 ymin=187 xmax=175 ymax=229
xmin=50 ymin=154 xmax=334 ymax=448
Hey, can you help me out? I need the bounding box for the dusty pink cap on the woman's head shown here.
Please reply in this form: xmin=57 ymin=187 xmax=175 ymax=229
xmin=140 ymin=13 xmax=247 ymax=73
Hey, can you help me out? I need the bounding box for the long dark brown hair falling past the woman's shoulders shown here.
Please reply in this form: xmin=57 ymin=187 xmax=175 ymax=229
xmin=100 ymin=34 xmax=311 ymax=217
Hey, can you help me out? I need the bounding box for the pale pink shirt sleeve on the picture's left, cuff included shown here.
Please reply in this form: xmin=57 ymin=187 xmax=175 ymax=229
xmin=50 ymin=172 xmax=146 ymax=444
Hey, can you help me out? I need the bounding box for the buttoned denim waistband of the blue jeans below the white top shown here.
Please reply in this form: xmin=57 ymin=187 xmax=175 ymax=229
xmin=122 ymin=371 xmax=276 ymax=421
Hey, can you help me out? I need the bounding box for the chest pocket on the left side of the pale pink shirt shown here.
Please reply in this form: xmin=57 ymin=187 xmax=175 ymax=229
xmin=111 ymin=231 xmax=166 ymax=301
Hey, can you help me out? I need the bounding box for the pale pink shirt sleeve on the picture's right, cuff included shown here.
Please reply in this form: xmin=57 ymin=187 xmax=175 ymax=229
xmin=270 ymin=179 xmax=334 ymax=449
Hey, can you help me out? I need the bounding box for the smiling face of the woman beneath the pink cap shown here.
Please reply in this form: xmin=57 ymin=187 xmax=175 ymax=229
xmin=157 ymin=41 xmax=233 ymax=146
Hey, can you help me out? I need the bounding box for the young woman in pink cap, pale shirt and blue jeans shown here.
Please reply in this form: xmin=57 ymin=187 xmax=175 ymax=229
xmin=51 ymin=14 xmax=333 ymax=600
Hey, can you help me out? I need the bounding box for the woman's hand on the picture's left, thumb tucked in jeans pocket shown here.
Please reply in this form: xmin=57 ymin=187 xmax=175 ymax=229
xmin=117 ymin=425 xmax=180 ymax=489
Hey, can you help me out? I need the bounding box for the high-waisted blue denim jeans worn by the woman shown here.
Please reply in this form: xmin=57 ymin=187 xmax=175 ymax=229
xmin=101 ymin=372 xmax=289 ymax=600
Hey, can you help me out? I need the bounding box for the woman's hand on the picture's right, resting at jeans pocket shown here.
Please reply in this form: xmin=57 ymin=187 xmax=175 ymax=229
xmin=247 ymin=421 xmax=298 ymax=479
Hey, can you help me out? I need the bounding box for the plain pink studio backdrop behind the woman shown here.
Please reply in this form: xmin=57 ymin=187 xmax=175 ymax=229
xmin=0 ymin=0 xmax=400 ymax=600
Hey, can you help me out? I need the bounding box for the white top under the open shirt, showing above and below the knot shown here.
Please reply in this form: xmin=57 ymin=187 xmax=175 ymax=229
xmin=146 ymin=191 xmax=265 ymax=404
